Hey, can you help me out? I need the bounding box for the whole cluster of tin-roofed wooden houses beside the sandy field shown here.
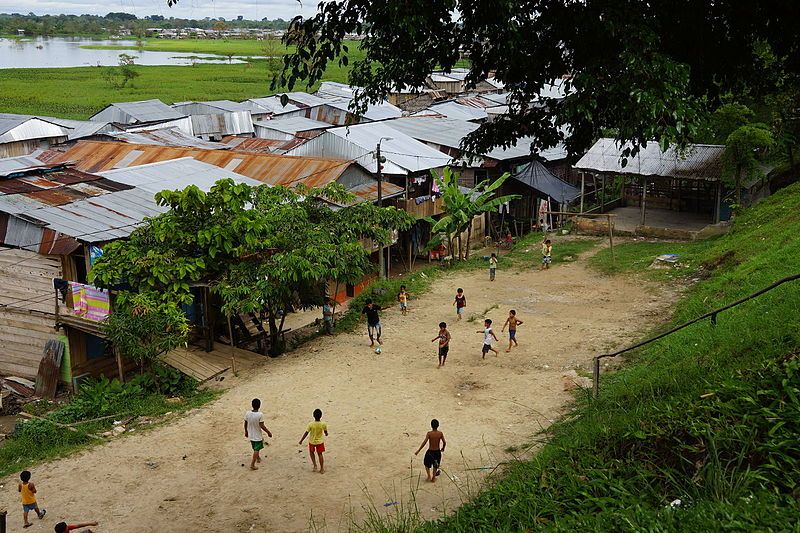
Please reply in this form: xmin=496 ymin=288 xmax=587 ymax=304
xmin=0 ymin=70 xmax=757 ymax=384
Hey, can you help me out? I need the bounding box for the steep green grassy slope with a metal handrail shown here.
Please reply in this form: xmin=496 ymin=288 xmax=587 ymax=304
xmin=418 ymin=184 xmax=800 ymax=531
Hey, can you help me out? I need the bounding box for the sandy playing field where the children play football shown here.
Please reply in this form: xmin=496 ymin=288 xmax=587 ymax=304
xmin=0 ymin=250 xmax=665 ymax=532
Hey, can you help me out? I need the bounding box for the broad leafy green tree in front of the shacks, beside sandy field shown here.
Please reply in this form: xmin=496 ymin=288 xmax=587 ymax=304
xmin=92 ymin=180 xmax=412 ymax=354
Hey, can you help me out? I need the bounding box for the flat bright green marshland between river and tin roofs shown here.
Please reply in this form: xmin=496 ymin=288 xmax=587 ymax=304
xmin=0 ymin=40 xmax=361 ymax=119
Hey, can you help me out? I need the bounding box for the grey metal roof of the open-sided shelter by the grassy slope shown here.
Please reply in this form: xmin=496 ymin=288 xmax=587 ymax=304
xmin=574 ymin=138 xmax=725 ymax=180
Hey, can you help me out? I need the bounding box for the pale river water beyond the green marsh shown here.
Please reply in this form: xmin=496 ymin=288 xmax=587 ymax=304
xmin=0 ymin=37 xmax=250 ymax=69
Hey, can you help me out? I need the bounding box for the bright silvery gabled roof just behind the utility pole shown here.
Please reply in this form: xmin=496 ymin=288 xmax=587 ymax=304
xmin=289 ymin=122 xmax=452 ymax=175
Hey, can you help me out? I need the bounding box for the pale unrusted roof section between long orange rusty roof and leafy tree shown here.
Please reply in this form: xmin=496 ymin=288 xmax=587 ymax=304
xmin=99 ymin=157 xmax=262 ymax=194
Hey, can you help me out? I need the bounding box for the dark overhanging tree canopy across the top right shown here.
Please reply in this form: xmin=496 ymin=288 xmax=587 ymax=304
xmin=276 ymin=0 xmax=800 ymax=158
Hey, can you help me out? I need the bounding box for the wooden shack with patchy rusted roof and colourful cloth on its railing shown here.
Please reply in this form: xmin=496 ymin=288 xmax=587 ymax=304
xmin=0 ymin=157 xmax=259 ymax=385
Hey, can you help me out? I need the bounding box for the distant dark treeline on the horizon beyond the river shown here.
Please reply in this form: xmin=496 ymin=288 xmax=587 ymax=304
xmin=0 ymin=13 xmax=289 ymax=37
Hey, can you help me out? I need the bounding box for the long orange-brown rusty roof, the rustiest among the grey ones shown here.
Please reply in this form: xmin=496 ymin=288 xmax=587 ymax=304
xmin=48 ymin=141 xmax=353 ymax=187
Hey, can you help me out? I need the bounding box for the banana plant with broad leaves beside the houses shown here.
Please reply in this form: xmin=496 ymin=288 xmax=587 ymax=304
xmin=427 ymin=167 xmax=520 ymax=259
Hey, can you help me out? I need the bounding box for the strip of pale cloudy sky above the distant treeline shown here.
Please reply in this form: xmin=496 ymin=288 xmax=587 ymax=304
xmin=0 ymin=0 xmax=319 ymax=20
